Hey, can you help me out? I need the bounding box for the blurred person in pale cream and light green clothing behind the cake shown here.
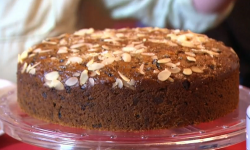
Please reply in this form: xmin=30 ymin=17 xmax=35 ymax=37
xmin=0 ymin=0 xmax=234 ymax=82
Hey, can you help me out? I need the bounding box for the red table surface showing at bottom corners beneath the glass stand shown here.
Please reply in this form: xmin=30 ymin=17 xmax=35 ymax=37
xmin=0 ymin=134 xmax=246 ymax=150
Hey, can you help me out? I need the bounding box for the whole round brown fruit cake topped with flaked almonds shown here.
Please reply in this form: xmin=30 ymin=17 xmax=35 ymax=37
xmin=17 ymin=27 xmax=239 ymax=131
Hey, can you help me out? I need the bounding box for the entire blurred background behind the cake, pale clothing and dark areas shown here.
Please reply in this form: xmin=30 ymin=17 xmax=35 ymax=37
xmin=0 ymin=0 xmax=250 ymax=87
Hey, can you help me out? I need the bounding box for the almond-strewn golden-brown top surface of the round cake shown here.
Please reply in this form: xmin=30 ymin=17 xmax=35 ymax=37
xmin=18 ymin=27 xmax=239 ymax=90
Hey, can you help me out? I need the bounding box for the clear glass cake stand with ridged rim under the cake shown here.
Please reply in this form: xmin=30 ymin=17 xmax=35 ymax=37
xmin=0 ymin=86 xmax=250 ymax=150
